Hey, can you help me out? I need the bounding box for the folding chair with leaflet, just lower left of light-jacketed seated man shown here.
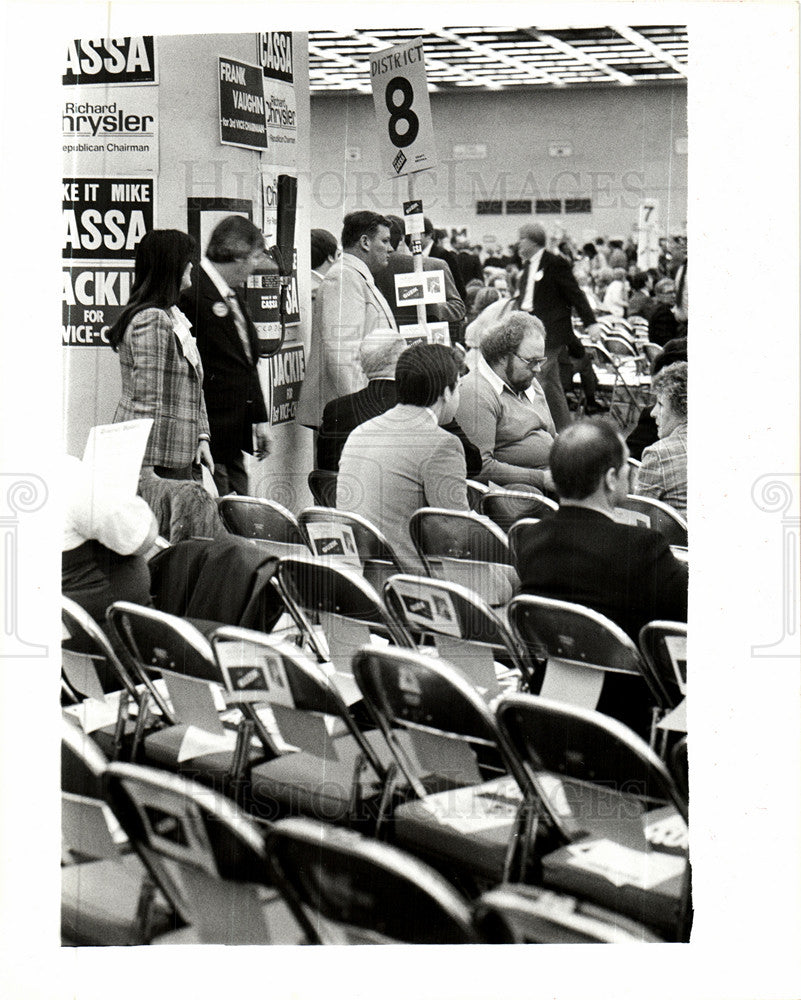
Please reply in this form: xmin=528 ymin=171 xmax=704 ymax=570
xmin=298 ymin=507 xmax=403 ymax=590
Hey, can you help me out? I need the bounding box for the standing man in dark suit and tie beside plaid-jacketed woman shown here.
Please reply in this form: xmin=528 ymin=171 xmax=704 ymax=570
xmin=179 ymin=215 xmax=271 ymax=496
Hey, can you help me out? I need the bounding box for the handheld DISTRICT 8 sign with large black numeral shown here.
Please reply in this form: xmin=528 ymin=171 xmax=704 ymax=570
xmin=370 ymin=38 xmax=437 ymax=177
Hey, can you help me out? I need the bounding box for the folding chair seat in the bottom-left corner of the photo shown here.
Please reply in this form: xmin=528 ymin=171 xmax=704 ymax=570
xmin=61 ymin=854 xmax=173 ymax=945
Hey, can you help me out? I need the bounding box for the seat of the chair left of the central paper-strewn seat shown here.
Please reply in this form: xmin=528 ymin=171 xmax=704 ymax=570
xmin=251 ymin=730 xmax=392 ymax=823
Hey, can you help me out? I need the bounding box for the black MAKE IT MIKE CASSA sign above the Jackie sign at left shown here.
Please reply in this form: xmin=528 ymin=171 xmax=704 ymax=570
xmin=61 ymin=177 xmax=155 ymax=263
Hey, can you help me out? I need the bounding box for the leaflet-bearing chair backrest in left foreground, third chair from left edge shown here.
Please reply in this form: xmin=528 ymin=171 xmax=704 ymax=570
xmin=211 ymin=626 xmax=386 ymax=779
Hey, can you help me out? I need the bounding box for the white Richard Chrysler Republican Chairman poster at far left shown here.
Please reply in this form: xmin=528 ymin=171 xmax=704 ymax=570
xmin=61 ymin=84 xmax=159 ymax=177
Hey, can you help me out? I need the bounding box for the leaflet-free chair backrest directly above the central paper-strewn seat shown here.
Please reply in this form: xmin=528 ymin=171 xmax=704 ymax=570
xmin=353 ymin=647 xmax=525 ymax=797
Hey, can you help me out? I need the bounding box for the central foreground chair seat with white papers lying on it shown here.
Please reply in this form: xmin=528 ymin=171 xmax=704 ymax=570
xmin=395 ymin=777 xmax=522 ymax=883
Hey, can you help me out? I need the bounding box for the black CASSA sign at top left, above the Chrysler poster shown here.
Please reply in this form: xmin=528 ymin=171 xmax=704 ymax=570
xmin=61 ymin=35 xmax=157 ymax=86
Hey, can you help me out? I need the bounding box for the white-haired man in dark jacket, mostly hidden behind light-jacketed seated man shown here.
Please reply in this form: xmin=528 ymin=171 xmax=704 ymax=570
xmin=317 ymin=330 xmax=481 ymax=478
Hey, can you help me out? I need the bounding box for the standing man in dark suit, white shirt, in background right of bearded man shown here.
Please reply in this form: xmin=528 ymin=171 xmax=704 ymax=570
xmin=517 ymin=223 xmax=601 ymax=431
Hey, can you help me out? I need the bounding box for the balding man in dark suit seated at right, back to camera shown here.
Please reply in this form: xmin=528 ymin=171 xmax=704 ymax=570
xmin=517 ymin=418 xmax=687 ymax=733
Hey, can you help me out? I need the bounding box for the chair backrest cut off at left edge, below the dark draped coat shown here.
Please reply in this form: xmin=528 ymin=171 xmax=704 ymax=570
xmin=61 ymin=597 xmax=136 ymax=698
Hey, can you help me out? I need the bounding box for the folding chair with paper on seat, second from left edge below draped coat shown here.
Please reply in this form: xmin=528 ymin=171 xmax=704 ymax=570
xmin=108 ymin=601 xmax=260 ymax=791
